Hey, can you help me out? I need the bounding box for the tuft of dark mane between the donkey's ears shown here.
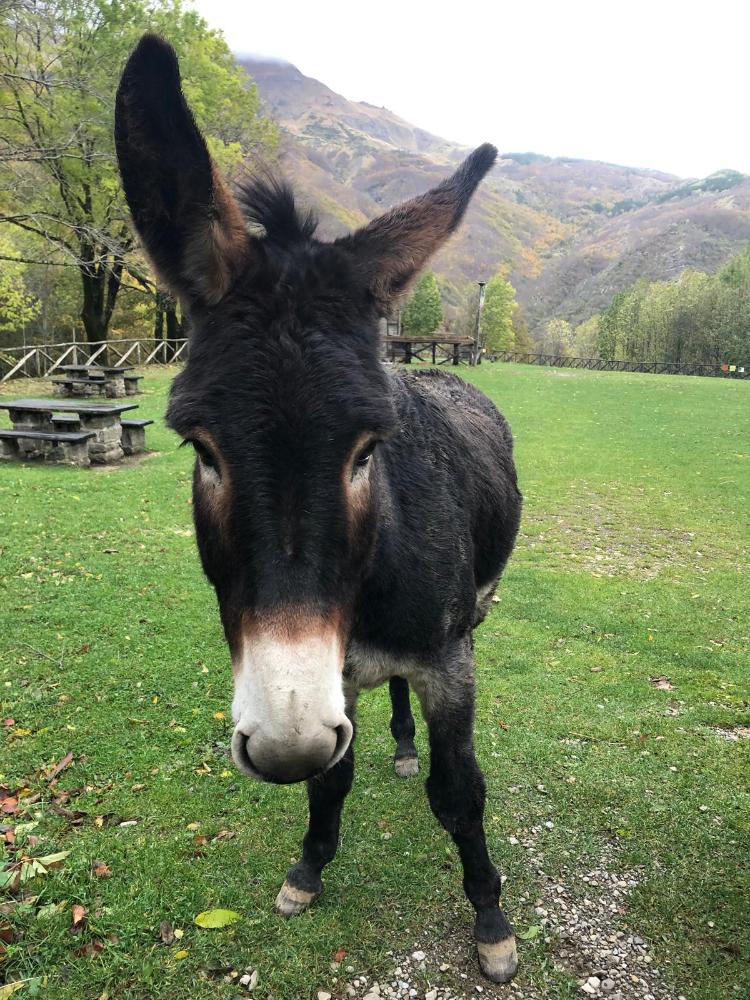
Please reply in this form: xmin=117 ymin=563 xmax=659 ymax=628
xmin=237 ymin=169 xmax=318 ymax=249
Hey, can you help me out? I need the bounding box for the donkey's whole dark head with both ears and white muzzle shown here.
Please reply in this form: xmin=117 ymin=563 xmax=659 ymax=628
xmin=116 ymin=35 xmax=496 ymax=782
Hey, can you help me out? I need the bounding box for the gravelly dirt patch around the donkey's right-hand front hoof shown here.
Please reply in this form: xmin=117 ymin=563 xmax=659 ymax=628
xmin=324 ymin=844 xmax=684 ymax=1000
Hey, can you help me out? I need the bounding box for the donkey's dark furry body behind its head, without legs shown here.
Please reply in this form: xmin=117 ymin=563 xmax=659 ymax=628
xmin=357 ymin=369 xmax=521 ymax=658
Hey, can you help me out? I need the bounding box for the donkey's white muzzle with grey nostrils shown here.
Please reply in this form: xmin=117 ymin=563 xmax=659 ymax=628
xmin=232 ymin=632 xmax=353 ymax=784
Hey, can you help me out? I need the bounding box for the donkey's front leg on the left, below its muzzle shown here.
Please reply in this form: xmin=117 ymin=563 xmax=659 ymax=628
xmin=275 ymin=720 xmax=354 ymax=917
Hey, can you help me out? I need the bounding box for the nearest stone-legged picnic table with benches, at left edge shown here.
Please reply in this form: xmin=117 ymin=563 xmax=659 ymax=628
xmin=0 ymin=399 xmax=140 ymax=465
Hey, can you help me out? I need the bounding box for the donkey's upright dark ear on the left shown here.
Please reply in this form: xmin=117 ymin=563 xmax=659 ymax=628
xmin=115 ymin=35 xmax=248 ymax=304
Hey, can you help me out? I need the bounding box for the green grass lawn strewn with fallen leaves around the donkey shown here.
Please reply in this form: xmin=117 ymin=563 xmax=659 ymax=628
xmin=0 ymin=364 xmax=750 ymax=1000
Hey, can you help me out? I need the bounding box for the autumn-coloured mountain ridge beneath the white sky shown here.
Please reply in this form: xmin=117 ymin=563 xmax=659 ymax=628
xmin=240 ymin=57 xmax=750 ymax=331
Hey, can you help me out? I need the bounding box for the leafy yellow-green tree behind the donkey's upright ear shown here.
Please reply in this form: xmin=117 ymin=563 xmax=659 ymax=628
xmin=0 ymin=0 xmax=275 ymax=341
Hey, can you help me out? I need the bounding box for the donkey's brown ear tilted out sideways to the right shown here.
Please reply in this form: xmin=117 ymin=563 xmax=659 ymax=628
xmin=336 ymin=143 xmax=497 ymax=315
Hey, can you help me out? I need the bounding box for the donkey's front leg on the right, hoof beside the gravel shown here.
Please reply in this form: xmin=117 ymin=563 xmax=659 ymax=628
xmin=420 ymin=660 xmax=518 ymax=983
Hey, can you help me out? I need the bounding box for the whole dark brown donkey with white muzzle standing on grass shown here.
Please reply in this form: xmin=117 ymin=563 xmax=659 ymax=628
xmin=115 ymin=35 xmax=521 ymax=982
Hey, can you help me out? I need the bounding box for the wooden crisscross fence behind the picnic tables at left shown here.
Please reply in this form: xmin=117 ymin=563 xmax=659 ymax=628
xmin=0 ymin=337 xmax=188 ymax=382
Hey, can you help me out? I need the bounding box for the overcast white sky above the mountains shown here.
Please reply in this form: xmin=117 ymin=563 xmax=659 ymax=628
xmin=194 ymin=0 xmax=750 ymax=176
